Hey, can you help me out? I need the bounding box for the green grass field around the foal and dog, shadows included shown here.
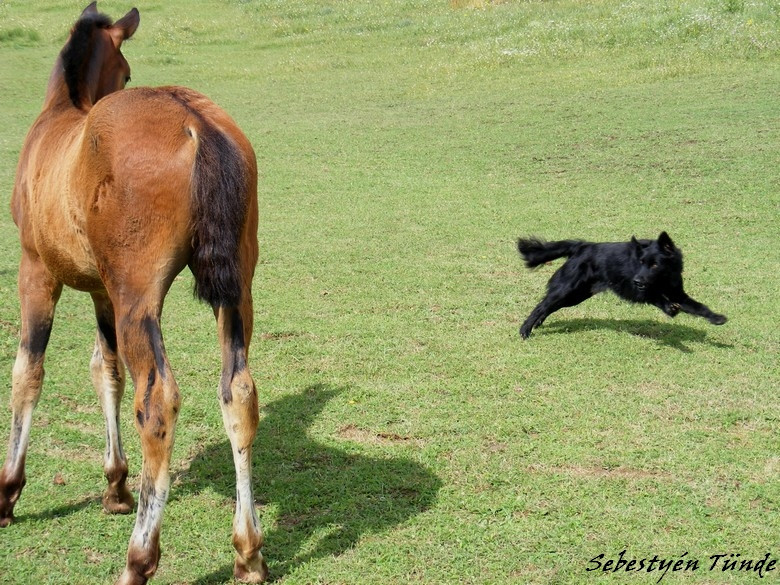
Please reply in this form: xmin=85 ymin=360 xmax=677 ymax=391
xmin=0 ymin=0 xmax=780 ymax=585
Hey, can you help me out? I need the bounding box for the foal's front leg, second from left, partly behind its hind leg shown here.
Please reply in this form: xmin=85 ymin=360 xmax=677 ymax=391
xmin=90 ymin=293 xmax=133 ymax=514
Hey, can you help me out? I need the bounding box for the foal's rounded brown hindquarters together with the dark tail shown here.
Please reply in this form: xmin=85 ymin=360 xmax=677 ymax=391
xmin=77 ymin=87 xmax=257 ymax=306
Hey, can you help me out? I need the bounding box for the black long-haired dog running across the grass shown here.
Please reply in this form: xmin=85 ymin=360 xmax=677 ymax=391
xmin=517 ymin=232 xmax=726 ymax=339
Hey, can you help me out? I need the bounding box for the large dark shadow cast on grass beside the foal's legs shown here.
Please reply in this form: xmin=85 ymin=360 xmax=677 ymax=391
xmin=176 ymin=385 xmax=441 ymax=585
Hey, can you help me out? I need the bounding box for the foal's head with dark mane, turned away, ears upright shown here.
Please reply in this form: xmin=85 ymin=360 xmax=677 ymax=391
xmin=47 ymin=2 xmax=139 ymax=110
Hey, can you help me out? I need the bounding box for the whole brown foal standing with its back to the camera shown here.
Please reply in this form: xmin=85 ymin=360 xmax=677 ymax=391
xmin=0 ymin=2 xmax=267 ymax=585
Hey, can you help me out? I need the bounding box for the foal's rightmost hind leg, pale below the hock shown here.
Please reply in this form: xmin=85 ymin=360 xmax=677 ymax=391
xmin=215 ymin=296 xmax=268 ymax=583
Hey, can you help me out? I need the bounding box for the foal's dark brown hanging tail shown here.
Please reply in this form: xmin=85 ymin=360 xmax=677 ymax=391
xmin=190 ymin=123 xmax=254 ymax=307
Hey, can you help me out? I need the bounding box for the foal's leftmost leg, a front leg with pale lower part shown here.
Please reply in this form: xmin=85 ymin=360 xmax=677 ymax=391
xmin=0 ymin=251 xmax=62 ymax=526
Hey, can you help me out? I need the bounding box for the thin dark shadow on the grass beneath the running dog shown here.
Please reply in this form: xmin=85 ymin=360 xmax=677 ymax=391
xmin=534 ymin=318 xmax=734 ymax=353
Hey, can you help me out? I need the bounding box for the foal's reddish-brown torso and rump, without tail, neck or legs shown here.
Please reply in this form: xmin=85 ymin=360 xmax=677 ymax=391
xmin=14 ymin=87 xmax=256 ymax=291
